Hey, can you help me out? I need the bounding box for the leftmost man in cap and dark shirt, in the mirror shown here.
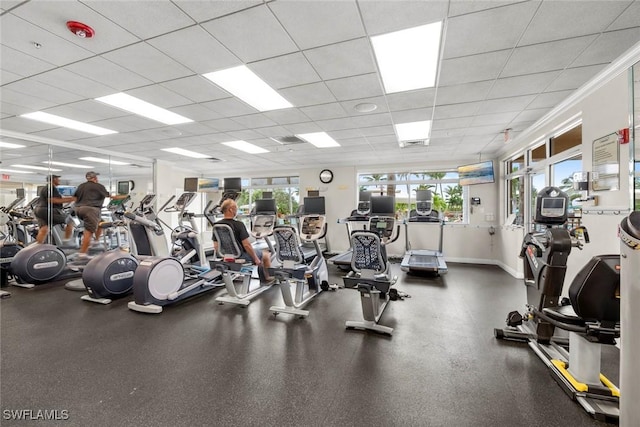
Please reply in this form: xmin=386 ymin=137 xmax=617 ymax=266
xmin=34 ymin=175 xmax=76 ymax=245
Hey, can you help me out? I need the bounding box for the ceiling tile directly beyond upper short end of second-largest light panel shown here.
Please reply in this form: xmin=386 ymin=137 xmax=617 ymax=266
xmin=148 ymin=26 xmax=241 ymax=74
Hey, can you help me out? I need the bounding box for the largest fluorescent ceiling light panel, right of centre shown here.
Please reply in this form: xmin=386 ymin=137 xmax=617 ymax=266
xmin=371 ymin=22 xmax=442 ymax=93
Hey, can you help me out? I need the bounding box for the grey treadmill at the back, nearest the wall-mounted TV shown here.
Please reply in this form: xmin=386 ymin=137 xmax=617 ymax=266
xmin=400 ymin=190 xmax=447 ymax=275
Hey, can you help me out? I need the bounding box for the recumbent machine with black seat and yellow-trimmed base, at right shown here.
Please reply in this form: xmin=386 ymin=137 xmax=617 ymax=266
xmin=494 ymin=187 xmax=620 ymax=422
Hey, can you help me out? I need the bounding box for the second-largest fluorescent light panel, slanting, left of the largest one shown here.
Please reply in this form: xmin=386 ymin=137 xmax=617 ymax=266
xmin=203 ymin=65 xmax=293 ymax=111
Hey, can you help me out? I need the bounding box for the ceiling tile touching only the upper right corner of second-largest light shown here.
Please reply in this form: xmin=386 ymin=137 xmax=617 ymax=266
xmin=202 ymin=6 xmax=298 ymax=63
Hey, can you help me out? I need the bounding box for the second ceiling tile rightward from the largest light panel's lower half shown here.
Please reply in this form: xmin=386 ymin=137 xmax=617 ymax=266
xmin=500 ymin=36 xmax=596 ymax=77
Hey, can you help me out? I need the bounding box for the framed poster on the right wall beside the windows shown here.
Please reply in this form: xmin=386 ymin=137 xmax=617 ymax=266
xmin=592 ymin=132 xmax=620 ymax=191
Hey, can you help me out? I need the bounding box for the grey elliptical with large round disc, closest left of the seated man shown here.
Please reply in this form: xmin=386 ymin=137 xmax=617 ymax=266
xmin=128 ymin=192 xmax=222 ymax=314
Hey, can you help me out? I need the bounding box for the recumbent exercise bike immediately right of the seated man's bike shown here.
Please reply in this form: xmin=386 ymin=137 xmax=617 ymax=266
xmin=269 ymin=209 xmax=337 ymax=318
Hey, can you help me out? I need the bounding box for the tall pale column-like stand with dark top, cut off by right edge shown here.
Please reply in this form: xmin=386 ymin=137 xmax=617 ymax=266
xmin=619 ymin=211 xmax=640 ymax=427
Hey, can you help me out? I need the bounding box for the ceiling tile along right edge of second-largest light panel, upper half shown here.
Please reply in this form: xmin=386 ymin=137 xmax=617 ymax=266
xmin=249 ymin=52 xmax=321 ymax=89
